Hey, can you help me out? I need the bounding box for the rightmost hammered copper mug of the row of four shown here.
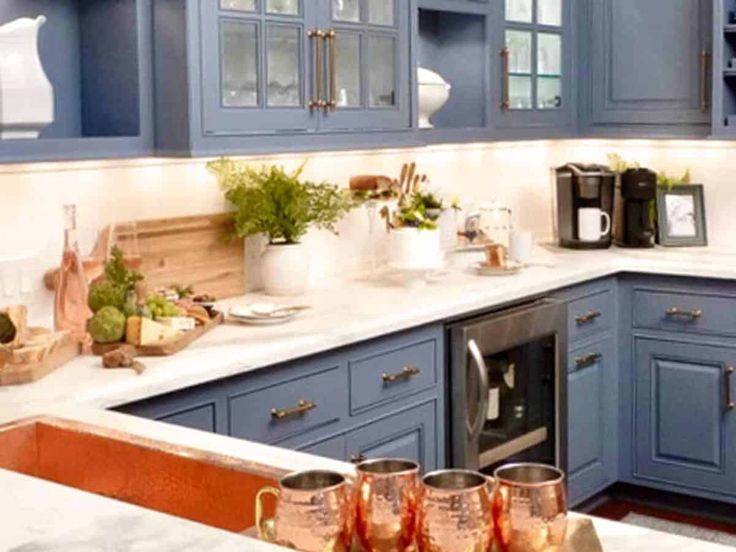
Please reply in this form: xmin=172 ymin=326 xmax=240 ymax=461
xmin=493 ymin=464 xmax=567 ymax=552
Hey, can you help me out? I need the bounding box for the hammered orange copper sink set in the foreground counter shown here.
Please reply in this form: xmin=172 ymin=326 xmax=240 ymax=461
xmin=0 ymin=418 xmax=284 ymax=533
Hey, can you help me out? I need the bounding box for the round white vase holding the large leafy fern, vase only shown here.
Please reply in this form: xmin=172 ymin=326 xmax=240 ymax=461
xmin=261 ymin=243 xmax=309 ymax=296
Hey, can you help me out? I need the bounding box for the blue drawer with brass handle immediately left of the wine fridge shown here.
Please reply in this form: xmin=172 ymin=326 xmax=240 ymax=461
xmin=348 ymin=337 xmax=438 ymax=414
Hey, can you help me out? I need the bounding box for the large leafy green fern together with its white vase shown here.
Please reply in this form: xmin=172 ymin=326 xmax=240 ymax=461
xmin=208 ymin=158 xmax=353 ymax=295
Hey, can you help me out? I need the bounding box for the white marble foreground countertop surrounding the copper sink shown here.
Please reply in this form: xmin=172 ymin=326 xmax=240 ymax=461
xmin=0 ymin=406 xmax=733 ymax=552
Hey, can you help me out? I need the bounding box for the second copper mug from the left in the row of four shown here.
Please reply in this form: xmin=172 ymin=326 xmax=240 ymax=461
xmin=355 ymin=459 xmax=419 ymax=552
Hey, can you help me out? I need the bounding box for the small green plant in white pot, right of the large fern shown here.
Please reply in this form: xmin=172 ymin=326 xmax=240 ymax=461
xmin=389 ymin=190 xmax=444 ymax=270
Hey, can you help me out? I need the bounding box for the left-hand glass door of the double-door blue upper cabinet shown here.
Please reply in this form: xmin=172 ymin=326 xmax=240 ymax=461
xmin=200 ymin=0 xmax=321 ymax=135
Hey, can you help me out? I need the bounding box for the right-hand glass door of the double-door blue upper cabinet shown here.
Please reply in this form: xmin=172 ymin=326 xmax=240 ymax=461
xmin=320 ymin=0 xmax=411 ymax=129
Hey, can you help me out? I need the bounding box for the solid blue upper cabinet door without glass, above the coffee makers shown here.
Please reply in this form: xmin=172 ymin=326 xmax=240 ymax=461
xmin=579 ymin=0 xmax=713 ymax=136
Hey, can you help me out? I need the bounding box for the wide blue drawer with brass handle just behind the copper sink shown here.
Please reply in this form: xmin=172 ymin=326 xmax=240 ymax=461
xmin=228 ymin=365 xmax=347 ymax=443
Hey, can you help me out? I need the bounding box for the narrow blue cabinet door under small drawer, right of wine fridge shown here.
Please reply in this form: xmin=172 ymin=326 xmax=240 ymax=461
xmin=568 ymin=338 xmax=618 ymax=505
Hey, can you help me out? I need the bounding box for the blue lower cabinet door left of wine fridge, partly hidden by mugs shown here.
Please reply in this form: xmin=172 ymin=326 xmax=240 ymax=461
xmin=346 ymin=401 xmax=440 ymax=472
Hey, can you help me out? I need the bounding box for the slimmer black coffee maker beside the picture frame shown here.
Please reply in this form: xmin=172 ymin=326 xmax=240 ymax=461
xmin=614 ymin=169 xmax=657 ymax=248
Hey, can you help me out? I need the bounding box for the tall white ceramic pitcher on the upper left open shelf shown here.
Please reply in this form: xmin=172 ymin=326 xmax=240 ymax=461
xmin=0 ymin=15 xmax=54 ymax=140
